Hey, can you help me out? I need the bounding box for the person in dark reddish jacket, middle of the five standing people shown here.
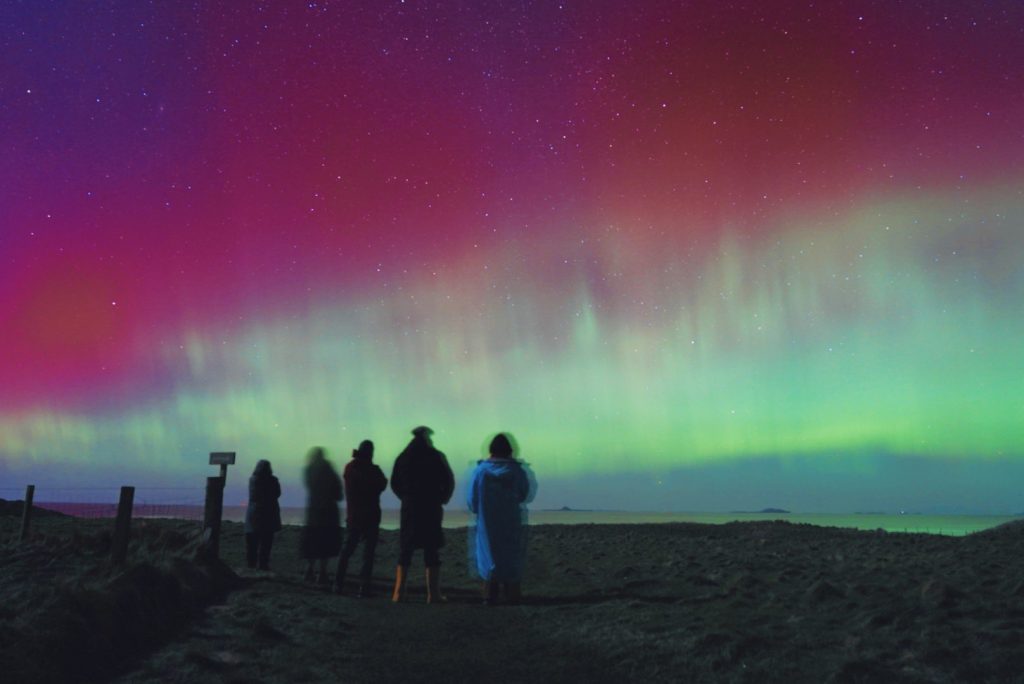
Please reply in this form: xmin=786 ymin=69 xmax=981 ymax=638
xmin=334 ymin=439 xmax=387 ymax=597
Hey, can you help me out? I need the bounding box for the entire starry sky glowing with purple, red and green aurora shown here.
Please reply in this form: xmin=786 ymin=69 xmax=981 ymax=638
xmin=0 ymin=0 xmax=1024 ymax=512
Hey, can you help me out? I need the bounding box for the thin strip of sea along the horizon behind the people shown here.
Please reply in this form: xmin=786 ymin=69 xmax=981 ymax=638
xmin=28 ymin=502 xmax=1024 ymax=537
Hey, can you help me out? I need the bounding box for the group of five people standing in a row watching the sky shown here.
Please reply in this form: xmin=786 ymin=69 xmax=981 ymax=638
xmin=245 ymin=426 xmax=531 ymax=605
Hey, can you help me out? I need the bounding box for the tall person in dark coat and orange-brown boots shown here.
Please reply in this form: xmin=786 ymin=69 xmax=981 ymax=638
xmin=391 ymin=426 xmax=455 ymax=603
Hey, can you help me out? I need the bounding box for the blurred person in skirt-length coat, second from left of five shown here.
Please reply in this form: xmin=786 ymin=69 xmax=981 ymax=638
xmin=302 ymin=446 xmax=343 ymax=585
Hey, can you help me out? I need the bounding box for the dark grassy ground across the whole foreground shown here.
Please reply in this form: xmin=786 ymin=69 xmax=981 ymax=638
xmin=0 ymin=499 xmax=1024 ymax=683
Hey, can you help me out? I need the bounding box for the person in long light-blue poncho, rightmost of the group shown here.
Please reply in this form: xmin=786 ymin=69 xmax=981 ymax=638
xmin=466 ymin=433 xmax=531 ymax=605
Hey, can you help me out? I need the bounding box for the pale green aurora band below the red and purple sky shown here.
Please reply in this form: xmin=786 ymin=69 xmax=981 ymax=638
xmin=0 ymin=184 xmax=1024 ymax=509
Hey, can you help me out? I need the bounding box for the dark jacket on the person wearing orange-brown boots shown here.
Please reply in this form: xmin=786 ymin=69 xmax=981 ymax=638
xmin=391 ymin=437 xmax=455 ymax=548
